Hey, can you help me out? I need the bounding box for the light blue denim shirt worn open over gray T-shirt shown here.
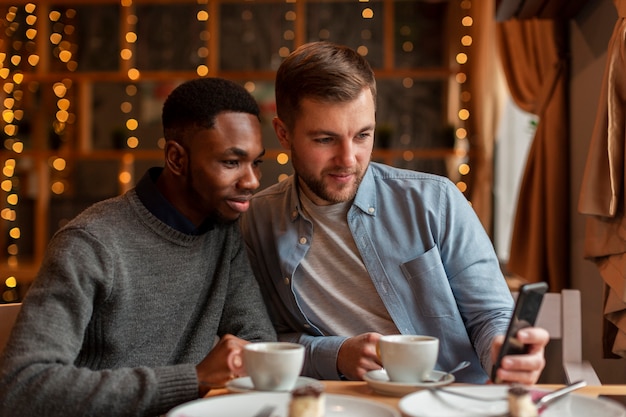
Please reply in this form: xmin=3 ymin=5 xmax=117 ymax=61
xmin=241 ymin=162 xmax=513 ymax=383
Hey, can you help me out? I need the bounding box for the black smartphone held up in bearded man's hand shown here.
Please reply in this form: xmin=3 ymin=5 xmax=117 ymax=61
xmin=491 ymin=282 xmax=548 ymax=383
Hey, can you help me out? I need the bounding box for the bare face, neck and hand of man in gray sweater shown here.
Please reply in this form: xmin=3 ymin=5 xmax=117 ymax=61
xmin=157 ymin=112 xmax=265 ymax=397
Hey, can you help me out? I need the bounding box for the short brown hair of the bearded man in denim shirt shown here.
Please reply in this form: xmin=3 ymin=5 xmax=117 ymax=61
xmin=275 ymin=41 xmax=376 ymax=129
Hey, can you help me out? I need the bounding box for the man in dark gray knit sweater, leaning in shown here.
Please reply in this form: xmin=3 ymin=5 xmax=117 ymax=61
xmin=0 ymin=78 xmax=276 ymax=417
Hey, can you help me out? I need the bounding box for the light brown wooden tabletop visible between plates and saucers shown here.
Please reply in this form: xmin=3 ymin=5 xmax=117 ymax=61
xmin=207 ymin=381 xmax=626 ymax=411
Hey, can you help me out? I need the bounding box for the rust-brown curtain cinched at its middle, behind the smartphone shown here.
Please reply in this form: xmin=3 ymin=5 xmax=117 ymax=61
xmin=497 ymin=19 xmax=570 ymax=291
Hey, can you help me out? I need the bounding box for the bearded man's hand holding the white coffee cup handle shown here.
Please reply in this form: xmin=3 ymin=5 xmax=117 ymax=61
xmin=337 ymin=333 xmax=382 ymax=380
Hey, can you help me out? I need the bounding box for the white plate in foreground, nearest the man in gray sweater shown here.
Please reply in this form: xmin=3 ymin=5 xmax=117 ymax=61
xmin=167 ymin=392 xmax=400 ymax=417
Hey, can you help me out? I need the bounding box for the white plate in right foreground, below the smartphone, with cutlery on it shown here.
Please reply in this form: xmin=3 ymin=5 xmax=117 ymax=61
xmin=399 ymin=385 xmax=626 ymax=417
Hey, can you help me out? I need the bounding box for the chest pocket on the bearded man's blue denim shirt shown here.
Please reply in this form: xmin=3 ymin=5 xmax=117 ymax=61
xmin=400 ymin=246 xmax=456 ymax=318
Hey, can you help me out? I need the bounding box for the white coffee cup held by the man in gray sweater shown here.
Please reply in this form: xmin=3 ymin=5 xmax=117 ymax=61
xmin=243 ymin=342 xmax=304 ymax=391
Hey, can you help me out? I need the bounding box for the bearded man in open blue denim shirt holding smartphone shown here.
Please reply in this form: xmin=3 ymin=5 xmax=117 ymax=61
xmin=242 ymin=42 xmax=549 ymax=384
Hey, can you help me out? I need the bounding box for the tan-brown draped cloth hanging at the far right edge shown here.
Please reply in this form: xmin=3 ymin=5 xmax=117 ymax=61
xmin=578 ymin=0 xmax=626 ymax=358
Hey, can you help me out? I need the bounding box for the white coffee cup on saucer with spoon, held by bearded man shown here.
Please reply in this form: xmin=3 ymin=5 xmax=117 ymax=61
xmin=378 ymin=335 xmax=439 ymax=383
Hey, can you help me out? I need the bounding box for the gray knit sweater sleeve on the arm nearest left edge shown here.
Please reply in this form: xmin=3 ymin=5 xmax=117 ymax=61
xmin=0 ymin=230 xmax=198 ymax=417
